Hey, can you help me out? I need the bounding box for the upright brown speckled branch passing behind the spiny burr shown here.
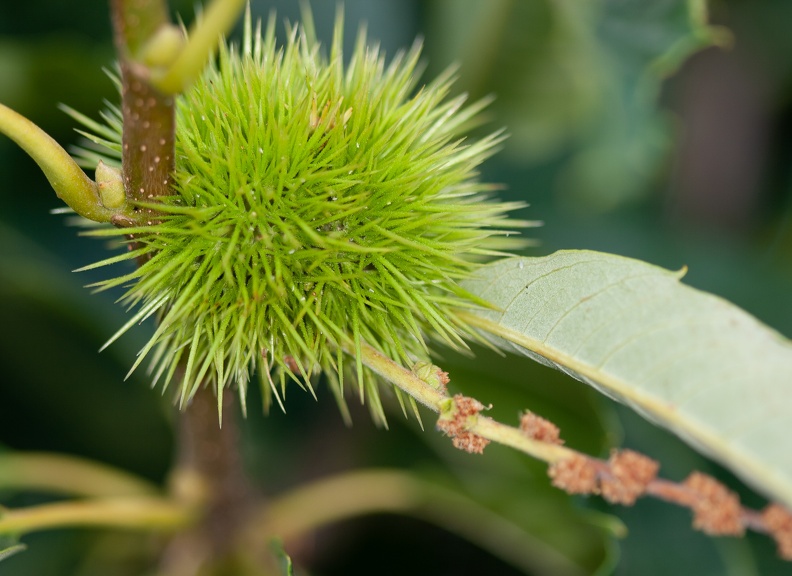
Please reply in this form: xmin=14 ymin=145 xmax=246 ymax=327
xmin=105 ymin=0 xmax=257 ymax=574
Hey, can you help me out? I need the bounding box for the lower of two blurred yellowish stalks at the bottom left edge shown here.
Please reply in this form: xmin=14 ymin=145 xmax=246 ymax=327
xmin=0 ymin=497 xmax=195 ymax=536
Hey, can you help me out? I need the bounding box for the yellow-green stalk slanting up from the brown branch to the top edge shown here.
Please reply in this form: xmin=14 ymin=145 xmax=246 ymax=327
xmin=151 ymin=0 xmax=246 ymax=94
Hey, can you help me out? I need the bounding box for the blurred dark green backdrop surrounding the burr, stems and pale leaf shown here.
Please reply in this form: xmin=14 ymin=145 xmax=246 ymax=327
xmin=0 ymin=0 xmax=792 ymax=576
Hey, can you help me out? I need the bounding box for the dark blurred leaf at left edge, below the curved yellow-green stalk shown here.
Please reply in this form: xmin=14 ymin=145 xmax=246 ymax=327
xmin=0 ymin=222 xmax=171 ymax=477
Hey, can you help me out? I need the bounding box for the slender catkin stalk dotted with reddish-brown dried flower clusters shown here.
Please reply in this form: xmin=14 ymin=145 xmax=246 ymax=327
xmin=361 ymin=346 xmax=792 ymax=560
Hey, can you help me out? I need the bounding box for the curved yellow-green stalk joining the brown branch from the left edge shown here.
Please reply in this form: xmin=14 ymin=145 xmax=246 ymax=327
xmin=0 ymin=104 xmax=118 ymax=222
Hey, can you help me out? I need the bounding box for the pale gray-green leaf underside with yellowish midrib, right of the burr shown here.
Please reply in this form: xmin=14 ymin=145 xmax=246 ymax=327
xmin=464 ymin=251 xmax=792 ymax=506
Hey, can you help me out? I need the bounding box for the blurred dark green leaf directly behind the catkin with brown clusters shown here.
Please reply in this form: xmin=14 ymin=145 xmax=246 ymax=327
xmin=408 ymin=347 xmax=623 ymax=573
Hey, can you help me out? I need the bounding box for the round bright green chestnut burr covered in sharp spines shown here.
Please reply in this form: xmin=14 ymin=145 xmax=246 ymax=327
xmin=74 ymin=11 xmax=522 ymax=418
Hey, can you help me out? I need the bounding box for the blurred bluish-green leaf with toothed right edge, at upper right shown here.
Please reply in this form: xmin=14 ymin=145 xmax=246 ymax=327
xmin=561 ymin=0 xmax=725 ymax=209
